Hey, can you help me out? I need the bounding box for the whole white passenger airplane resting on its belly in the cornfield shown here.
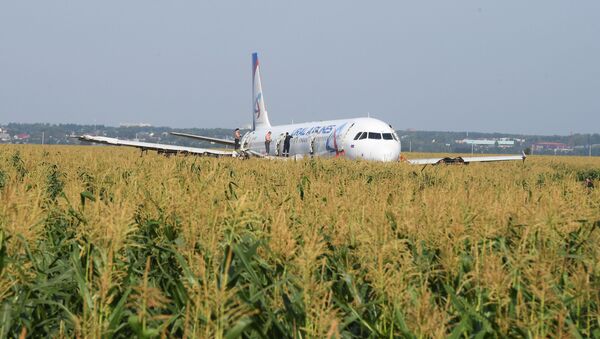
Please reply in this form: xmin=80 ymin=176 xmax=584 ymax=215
xmin=78 ymin=53 xmax=525 ymax=165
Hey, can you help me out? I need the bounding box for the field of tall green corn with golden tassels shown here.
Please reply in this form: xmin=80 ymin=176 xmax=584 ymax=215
xmin=0 ymin=145 xmax=600 ymax=338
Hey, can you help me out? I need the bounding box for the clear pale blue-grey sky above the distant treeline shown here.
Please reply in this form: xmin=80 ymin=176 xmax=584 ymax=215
xmin=0 ymin=0 xmax=600 ymax=135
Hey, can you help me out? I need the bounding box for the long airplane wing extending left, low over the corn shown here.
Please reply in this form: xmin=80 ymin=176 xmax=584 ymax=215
xmin=77 ymin=134 xmax=238 ymax=157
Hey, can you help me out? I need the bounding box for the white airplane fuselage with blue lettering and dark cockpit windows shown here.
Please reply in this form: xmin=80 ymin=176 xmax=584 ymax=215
xmin=241 ymin=118 xmax=400 ymax=161
